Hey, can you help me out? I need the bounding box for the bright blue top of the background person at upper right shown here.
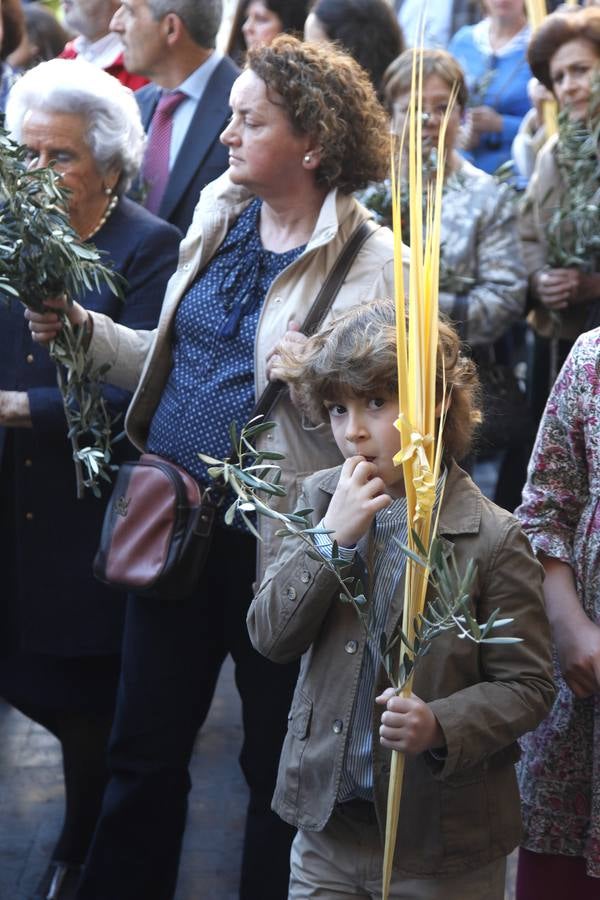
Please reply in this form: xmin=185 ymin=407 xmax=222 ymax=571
xmin=448 ymin=23 xmax=532 ymax=174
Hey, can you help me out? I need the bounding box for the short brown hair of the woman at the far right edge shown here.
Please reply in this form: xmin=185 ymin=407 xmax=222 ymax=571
xmin=527 ymin=6 xmax=600 ymax=91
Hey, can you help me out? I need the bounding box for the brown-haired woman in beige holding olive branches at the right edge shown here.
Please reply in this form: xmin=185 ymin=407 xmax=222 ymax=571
xmin=519 ymin=7 xmax=600 ymax=418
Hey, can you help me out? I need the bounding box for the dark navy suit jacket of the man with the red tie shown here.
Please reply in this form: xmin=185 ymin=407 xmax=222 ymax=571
xmin=135 ymin=57 xmax=240 ymax=234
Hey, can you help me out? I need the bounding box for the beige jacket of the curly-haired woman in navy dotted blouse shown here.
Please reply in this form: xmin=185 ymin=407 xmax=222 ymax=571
xmin=90 ymin=173 xmax=400 ymax=580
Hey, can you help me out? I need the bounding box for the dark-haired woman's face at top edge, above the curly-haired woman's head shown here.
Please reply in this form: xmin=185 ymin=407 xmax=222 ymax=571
xmin=226 ymin=0 xmax=308 ymax=65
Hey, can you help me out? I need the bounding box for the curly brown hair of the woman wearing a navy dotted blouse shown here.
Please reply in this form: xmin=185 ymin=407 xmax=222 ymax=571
xmin=246 ymin=35 xmax=390 ymax=194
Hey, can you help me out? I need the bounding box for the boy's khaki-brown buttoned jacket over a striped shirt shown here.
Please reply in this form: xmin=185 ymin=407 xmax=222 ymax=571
xmin=248 ymin=464 xmax=554 ymax=876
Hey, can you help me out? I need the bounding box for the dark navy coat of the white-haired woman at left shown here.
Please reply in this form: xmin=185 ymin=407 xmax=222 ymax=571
xmin=0 ymin=199 xmax=181 ymax=657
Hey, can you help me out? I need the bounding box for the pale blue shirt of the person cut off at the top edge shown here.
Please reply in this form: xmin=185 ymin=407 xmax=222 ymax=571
xmin=393 ymin=0 xmax=483 ymax=50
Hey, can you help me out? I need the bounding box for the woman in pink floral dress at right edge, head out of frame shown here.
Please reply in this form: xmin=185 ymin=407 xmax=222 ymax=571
xmin=516 ymin=329 xmax=600 ymax=900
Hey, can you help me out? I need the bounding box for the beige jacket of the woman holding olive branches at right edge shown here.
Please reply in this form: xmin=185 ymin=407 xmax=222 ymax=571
xmin=519 ymin=135 xmax=590 ymax=341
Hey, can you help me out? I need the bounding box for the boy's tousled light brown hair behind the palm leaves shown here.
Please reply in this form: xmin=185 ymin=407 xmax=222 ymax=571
xmin=281 ymin=300 xmax=481 ymax=460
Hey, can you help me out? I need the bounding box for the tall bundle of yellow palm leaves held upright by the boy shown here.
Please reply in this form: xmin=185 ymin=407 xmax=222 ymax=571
xmin=382 ymin=51 xmax=454 ymax=900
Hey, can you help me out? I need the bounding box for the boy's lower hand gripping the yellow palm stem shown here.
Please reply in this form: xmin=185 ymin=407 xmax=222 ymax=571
xmin=375 ymin=688 xmax=445 ymax=755
